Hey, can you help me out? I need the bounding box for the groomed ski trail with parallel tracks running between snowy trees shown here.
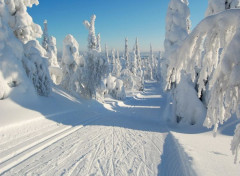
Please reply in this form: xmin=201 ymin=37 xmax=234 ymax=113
xmin=0 ymin=82 xmax=180 ymax=176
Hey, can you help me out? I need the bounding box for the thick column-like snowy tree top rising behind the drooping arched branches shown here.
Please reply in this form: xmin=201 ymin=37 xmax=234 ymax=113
xmin=164 ymin=0 xmax=191 ymax=57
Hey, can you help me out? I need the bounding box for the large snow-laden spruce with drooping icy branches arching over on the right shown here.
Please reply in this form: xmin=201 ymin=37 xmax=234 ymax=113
xmin=167 ymin=9 xmax=240 ymax=163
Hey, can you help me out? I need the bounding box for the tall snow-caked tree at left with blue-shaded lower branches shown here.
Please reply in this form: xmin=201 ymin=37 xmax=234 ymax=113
xmin=1 ymin=0 xmax=51 ymax=96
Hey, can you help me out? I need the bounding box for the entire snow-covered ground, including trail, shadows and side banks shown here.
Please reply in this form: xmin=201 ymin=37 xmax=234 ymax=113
xmin=0 ymin=82 xmax=240 ymax=176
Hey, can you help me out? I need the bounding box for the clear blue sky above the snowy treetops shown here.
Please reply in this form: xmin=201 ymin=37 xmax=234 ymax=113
xmin=28 ymin=0 xmax=207 ymax=51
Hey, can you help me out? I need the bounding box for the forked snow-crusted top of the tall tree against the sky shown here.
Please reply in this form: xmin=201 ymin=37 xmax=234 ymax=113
xmin=83 ymin=15 xmax=97 ymax=50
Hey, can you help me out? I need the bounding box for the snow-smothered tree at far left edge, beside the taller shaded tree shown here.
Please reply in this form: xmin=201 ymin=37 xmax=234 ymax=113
xmin=0 ymin=0 xmax=35 ymax=100
